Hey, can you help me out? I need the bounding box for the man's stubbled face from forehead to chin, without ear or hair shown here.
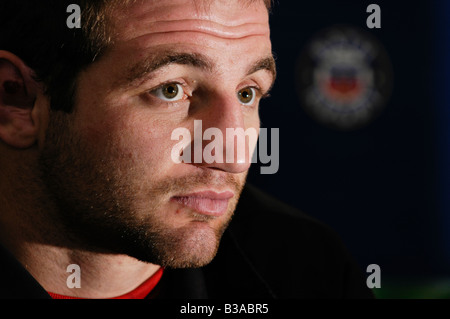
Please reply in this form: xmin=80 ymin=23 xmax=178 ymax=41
xmin=41 ymin=0 xmax=273 ymax=267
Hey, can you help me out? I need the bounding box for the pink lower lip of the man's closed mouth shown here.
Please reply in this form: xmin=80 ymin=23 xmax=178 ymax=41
xmin=171 ymin=196 xmax=229 ymax=217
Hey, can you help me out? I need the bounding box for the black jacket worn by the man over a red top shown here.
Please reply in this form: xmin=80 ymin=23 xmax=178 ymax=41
xmin=0 ymin=185 xmax=373 ymax=299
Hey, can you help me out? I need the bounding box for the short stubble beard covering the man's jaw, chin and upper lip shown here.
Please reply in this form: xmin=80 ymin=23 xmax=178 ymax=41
xmin=39 ymin=112 xmax=245 ymax=268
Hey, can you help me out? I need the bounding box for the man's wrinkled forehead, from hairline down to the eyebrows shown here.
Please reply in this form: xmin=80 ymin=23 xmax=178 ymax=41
xmin=85 ymin=0 xmax=275 ymax=92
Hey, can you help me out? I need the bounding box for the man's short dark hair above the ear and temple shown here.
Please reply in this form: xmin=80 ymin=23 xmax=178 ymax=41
xmin=0 ymin=0 xmax=271 ymax=112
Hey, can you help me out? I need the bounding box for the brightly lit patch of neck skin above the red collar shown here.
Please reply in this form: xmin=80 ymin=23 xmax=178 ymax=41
xmin=19 ymin=243 xmax=159 ymax=299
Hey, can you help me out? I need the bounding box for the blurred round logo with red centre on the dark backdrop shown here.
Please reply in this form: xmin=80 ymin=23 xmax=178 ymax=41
xmin=296 ymin=26 xmax=392 ymax=130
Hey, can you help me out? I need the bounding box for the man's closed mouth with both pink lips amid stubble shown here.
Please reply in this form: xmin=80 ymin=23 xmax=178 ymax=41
xmin=170 ymin=191 xmax=234 ymax=217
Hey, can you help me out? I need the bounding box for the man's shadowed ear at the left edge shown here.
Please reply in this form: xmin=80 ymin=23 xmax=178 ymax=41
xmin=0 ymin=50 xmax=39 ymax=149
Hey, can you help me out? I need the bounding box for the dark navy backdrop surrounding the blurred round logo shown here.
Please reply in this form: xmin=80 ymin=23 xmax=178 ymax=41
xmin=249 ymin=0 xmax=450 ymax=298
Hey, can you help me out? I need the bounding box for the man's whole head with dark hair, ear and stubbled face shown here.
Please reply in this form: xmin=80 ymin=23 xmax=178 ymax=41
xmin=0 ymin=0 xmax=275 ymax=267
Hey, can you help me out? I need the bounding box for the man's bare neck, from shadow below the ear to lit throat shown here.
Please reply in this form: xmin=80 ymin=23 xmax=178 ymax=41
xmin=0 ymin=155 xmax=160 ymax=298
